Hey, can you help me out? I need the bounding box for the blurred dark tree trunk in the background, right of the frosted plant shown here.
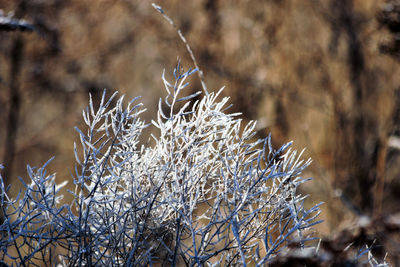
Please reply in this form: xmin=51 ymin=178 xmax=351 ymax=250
xmin=330 ymin=0 xmax=381 ymax=214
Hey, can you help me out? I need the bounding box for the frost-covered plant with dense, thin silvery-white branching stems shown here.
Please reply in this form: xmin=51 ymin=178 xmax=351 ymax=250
xmin=0 ymin=64 xmax=320 ymax=266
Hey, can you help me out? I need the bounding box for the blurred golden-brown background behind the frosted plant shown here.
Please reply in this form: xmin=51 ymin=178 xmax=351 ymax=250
xmin=0 ymin=0 xmax=400 ymax=266
